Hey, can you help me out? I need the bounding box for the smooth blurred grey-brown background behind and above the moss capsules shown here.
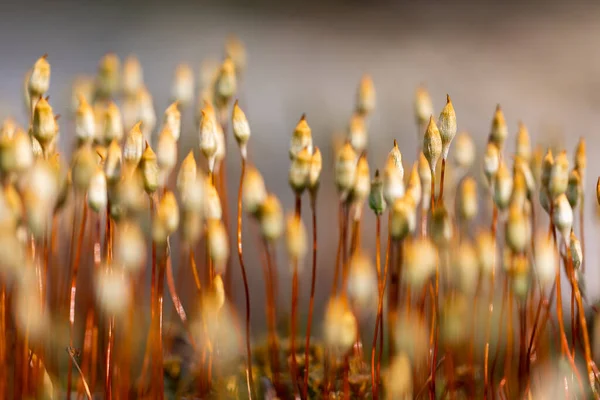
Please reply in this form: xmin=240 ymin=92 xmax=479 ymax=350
xmin=0 ymin=0 xmax=600 ymax=334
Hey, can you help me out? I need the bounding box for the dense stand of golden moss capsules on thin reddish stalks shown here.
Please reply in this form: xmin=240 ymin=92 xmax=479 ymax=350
xmin=0 ymin=34 xmax=600 ymax=399
